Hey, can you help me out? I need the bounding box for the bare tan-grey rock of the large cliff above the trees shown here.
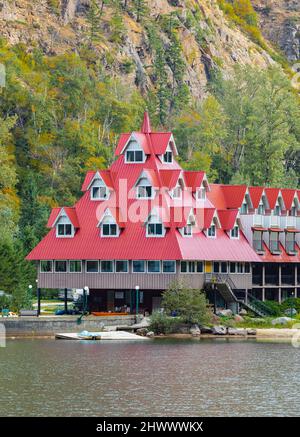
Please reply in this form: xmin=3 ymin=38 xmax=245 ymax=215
xmin=0 ymin=0 xmax=278 ymax=98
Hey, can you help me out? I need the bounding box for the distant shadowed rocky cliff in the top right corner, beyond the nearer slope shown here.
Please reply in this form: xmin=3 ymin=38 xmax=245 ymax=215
xmin=252 ymin=0 xmax=300 ymax=63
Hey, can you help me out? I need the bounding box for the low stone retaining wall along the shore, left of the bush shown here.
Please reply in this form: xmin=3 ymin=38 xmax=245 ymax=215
xmin=0 ymin=316 xmax=135 ymax=337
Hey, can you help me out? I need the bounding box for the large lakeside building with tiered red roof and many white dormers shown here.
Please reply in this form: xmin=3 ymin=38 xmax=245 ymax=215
xmin=27 ymin=113 xmax=300 ymax=314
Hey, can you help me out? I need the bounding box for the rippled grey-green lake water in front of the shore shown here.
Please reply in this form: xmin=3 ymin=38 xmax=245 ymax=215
xmin=0 ymin=339 xmax=300 ymax=416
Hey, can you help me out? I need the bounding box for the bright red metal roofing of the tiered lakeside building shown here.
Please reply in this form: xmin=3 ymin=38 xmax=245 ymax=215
xmin=27 ymin=114 xmax=300 ymax=262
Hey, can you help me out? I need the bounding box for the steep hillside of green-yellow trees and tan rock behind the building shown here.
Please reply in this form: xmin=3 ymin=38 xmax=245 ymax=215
xmin=0 ymin=0 xmax=300 ymax=305
